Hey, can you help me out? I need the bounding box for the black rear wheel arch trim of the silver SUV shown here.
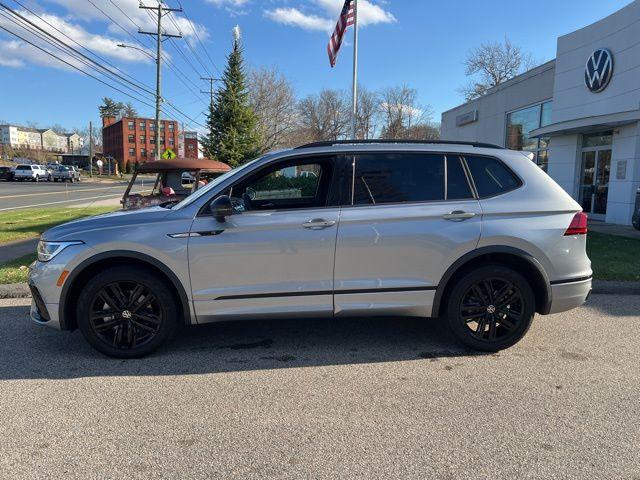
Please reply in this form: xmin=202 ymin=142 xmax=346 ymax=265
xmin=431 ymin=245 xmax=551 ymax=317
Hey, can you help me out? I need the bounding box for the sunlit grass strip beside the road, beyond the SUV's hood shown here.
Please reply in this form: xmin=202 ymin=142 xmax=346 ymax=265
xmin=0 ymin=207 xmax=117 ymax=245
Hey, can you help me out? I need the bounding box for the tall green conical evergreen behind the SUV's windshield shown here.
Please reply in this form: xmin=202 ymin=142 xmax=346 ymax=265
xmin=202 ymin=27 xmax=259 ymax=167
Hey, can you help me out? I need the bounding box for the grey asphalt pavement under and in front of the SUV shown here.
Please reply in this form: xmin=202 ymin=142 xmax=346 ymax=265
xmin=0 ymin=295 xmax=640 ymax=480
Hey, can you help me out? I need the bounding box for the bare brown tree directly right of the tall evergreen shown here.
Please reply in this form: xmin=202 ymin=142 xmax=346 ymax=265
xmin=249 ymin=68 xmax=296 ymax=153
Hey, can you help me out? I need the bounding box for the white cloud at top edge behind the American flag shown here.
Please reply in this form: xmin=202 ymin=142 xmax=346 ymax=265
xmin=264 ymin=0 xmax=397 ymax=31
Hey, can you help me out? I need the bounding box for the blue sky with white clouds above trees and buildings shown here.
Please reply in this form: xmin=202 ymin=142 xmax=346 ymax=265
xmin=0 ymin=0 xmax=630 ymax=130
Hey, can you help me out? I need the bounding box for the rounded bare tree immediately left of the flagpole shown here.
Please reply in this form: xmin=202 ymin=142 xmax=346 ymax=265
xmin=297 ymin=90 xmax=351 ymax=141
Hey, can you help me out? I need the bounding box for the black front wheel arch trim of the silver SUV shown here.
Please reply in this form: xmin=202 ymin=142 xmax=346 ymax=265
xmin=58 ymin=250 xmax=192 ymax=330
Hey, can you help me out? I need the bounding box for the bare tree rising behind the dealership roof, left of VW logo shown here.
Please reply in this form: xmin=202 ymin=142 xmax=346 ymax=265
xmin=460 ymin=37 xmax=533 ymax=101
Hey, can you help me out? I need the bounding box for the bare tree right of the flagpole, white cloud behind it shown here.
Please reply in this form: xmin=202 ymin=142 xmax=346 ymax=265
xmin=380 ymin=85 xmax=433 ymax=139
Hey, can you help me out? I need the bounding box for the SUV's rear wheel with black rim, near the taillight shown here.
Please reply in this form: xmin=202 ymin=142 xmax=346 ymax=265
xmin=446 ymin=265 xmax=536 ymax=352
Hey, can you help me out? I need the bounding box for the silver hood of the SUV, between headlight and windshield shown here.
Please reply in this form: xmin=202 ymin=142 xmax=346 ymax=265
xmin=41 ymin=207 xmax=171 ymax=242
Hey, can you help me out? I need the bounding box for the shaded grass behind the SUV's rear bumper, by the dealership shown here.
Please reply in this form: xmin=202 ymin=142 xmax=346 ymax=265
xmin=587 ymin=232 xmax=640 ymax=280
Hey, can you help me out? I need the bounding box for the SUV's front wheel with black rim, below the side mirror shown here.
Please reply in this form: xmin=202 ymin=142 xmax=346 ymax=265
xmin=77 ymin=267 xmax=178 ymax=358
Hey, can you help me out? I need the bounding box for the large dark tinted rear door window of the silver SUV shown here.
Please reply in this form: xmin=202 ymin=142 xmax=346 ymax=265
xmin=354 ymin=153 xmax=444 ymax=205
